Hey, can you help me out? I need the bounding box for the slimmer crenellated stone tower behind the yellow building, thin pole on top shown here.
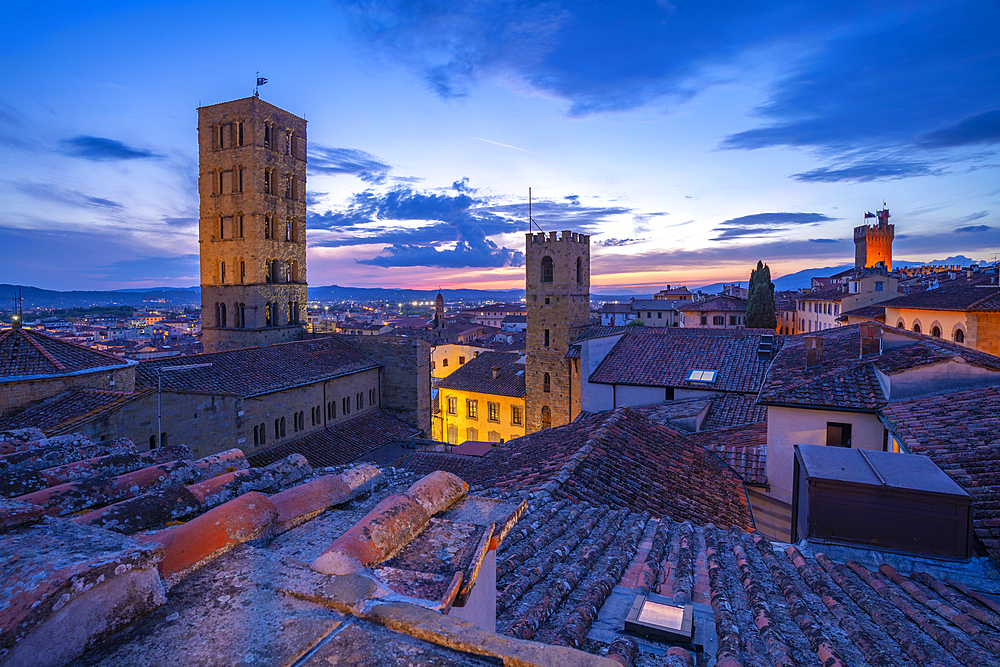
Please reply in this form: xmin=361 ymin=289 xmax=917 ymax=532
xmin=525 ymin=231 xmax=590 ymax=433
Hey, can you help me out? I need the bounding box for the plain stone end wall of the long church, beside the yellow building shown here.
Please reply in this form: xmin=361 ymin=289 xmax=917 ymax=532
xmin=336 ymin=335 xmax=431 ymax=437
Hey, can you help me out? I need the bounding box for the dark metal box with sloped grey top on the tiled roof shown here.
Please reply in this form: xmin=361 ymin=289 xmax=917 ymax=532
xmin=792 ymin=445 xmax=972 ymax=559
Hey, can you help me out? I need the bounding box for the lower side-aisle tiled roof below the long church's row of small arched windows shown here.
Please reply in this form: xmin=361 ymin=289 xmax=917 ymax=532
xmin=250 ymin=409 xmax=421 ymax=468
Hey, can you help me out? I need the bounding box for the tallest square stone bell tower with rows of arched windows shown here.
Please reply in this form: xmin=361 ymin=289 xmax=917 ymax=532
xmin=198 ymin=96 xmax=306 ymax=352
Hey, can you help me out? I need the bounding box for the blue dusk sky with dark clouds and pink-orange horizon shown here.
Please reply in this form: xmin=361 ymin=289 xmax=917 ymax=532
xmin=0 ymin=0 xmax=1000 ymax=292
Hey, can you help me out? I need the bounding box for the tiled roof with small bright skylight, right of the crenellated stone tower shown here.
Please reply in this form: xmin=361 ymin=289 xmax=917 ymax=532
xmin=590 ymin=329 xmax=784 ymax=393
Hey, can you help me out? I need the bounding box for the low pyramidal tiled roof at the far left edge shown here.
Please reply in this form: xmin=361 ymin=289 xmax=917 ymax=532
xmin=0 ymin=329 xmax=128 ymax=379
